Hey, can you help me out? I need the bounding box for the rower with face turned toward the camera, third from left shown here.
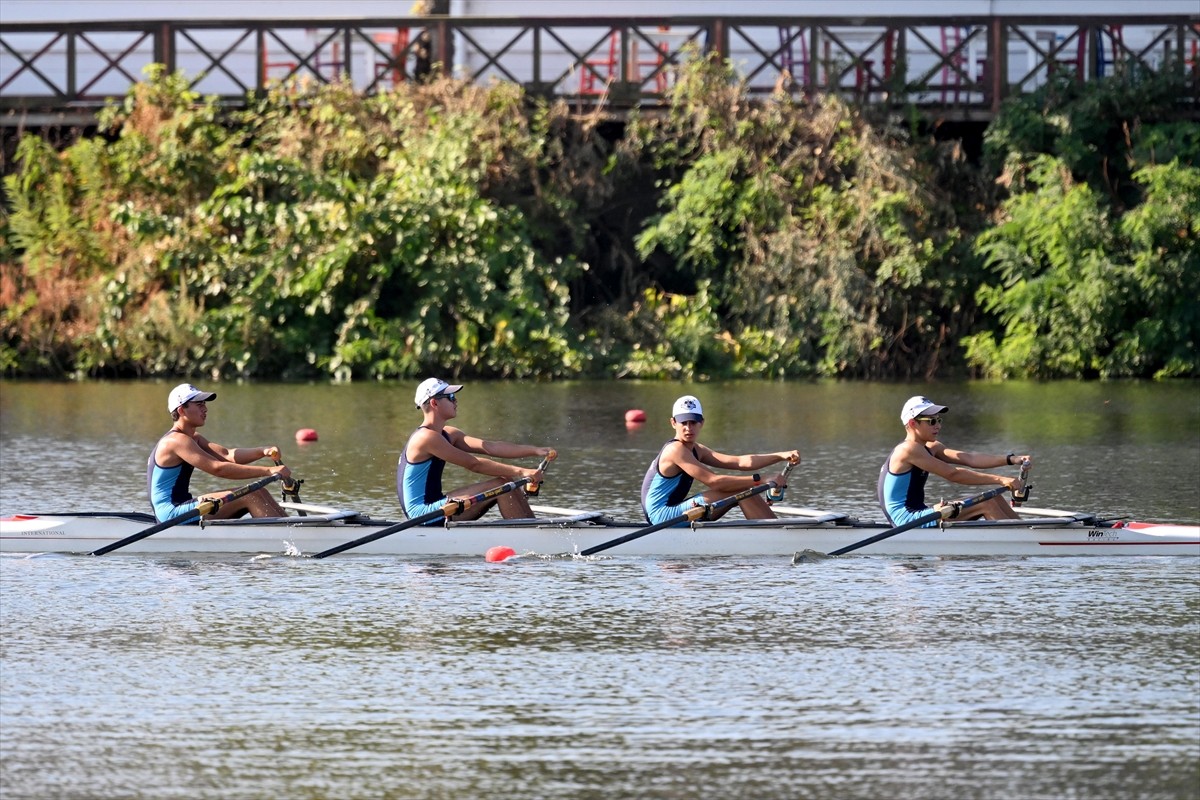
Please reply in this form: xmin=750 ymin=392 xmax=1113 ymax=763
xmin=642 ymin=395 xmax=800 ymax=525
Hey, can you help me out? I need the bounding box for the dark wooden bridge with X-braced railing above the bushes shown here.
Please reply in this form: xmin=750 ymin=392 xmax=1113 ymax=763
xmin=0 ymin=13 xmax=1200 ymax=127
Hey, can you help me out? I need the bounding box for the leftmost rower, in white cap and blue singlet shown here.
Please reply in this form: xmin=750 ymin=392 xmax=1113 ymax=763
xmin=146 ymin=384 xmax=292 ymax=522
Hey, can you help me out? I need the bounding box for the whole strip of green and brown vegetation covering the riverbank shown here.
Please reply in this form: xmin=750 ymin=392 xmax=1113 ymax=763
xmin=0 ymin=61 xmax=1200 ymax=380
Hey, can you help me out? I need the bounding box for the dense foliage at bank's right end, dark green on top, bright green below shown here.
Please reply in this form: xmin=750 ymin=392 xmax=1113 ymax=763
xmin=964 ymin=71 xmax=1200 ymax=378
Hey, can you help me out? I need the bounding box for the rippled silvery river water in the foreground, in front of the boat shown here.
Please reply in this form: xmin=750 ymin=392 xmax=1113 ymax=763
xmin=0 ymin=555 xmax=1200 ymax=800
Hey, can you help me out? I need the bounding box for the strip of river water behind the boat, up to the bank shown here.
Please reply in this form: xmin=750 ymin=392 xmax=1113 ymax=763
xmin=0 ymin=381 xmax=1200 ymax=521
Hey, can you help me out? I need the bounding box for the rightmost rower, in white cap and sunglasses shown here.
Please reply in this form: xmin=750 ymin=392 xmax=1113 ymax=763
xmin=877 ymin=395 xmax=1033 ymax=528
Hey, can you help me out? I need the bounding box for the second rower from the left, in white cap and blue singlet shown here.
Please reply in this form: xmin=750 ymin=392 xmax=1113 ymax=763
xmin=396 ymin=378 xmax=558 ymax=524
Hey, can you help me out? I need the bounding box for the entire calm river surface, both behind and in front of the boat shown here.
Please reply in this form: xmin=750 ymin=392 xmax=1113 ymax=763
xmin=0 ymin=381 xmax=1200 ymax=800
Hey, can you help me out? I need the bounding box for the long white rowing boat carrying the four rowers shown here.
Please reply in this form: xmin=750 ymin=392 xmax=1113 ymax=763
xmin=0 ymin=503 xmax=1200 ymax=558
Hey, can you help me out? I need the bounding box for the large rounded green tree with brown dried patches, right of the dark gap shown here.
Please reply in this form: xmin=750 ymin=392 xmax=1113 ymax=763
xmin=631 ymin=53 xmax=976 ymax=377
